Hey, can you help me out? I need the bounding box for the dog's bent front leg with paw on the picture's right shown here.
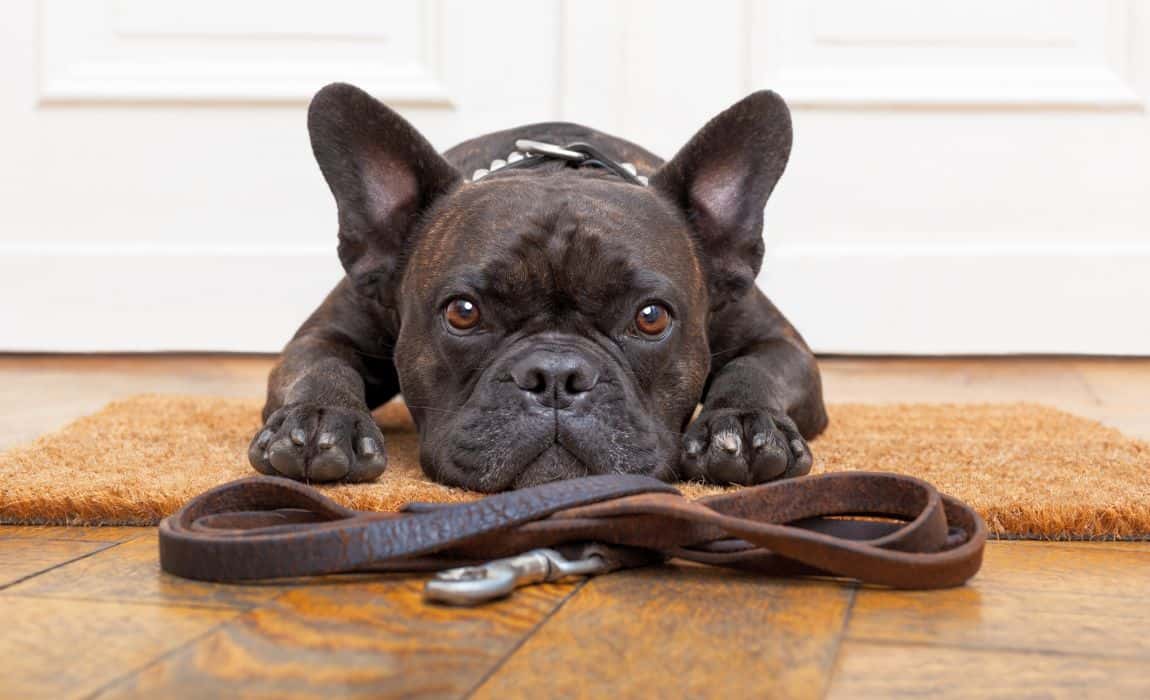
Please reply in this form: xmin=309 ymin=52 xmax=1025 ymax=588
xmin=682 ymin=292 xmax=827 ymax=484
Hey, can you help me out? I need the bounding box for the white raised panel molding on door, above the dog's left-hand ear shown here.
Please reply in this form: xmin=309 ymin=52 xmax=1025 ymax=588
xmin=39 ymin=0 xmax=452 ymax=107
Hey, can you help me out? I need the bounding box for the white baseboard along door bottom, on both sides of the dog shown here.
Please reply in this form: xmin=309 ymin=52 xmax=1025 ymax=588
xmin=0 ymin=242 xmax=1150 ymax=355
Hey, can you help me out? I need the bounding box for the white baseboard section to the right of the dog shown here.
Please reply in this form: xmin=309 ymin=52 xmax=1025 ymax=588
xmin=759 ymin=243 xmax=1150 ymax=355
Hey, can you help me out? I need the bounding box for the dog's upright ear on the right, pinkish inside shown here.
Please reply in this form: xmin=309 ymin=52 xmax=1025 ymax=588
xmin=651 ymin=91 xmax=791 ymax=308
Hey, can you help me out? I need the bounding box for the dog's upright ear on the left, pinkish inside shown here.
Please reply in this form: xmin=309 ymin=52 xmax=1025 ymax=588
xmin=307 ymin=83 xmax=461 ymax=306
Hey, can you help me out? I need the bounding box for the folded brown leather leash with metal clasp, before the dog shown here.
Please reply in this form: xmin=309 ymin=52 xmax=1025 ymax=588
xmin=160 ymin=471 xmax=987 ymax=605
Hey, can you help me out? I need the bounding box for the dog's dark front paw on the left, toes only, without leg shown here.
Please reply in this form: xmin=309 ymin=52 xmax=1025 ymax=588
xmin=247 ymin=403 xmax=388 ymax=482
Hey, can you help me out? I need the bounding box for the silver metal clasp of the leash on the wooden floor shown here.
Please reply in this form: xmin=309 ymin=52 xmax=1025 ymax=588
xmin=423 ymin=548 xmax=610 ymax=606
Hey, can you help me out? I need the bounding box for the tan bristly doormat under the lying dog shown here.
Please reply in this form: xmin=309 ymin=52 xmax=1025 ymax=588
xmin=0 ymin=395 xmax=1150 ymax=539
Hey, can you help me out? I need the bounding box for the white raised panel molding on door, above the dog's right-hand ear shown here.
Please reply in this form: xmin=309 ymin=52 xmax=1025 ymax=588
xmin=746 ymin=0 xmax=1145 ymax=109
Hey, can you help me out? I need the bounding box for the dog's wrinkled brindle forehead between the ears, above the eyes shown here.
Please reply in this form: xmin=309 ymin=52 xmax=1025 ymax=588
xmin=408 ymin=177 xmax=704 ymax=301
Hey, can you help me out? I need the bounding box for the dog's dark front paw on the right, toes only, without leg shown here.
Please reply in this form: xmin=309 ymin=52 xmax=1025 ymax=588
xmin=682 ymin=408 xmax=812 ymax=484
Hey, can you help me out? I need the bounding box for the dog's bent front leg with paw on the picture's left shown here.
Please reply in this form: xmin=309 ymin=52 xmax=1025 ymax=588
xmin=248 ymin=310 xmax=398 ymax=482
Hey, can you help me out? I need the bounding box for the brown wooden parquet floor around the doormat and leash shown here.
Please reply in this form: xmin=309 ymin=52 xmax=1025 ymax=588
xmin=0 ymin=356 xmax=1150 ymax=698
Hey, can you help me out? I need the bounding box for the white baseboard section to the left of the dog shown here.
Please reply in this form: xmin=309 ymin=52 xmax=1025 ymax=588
xmin=0 ymin=244 xmax=343 ymax=352
